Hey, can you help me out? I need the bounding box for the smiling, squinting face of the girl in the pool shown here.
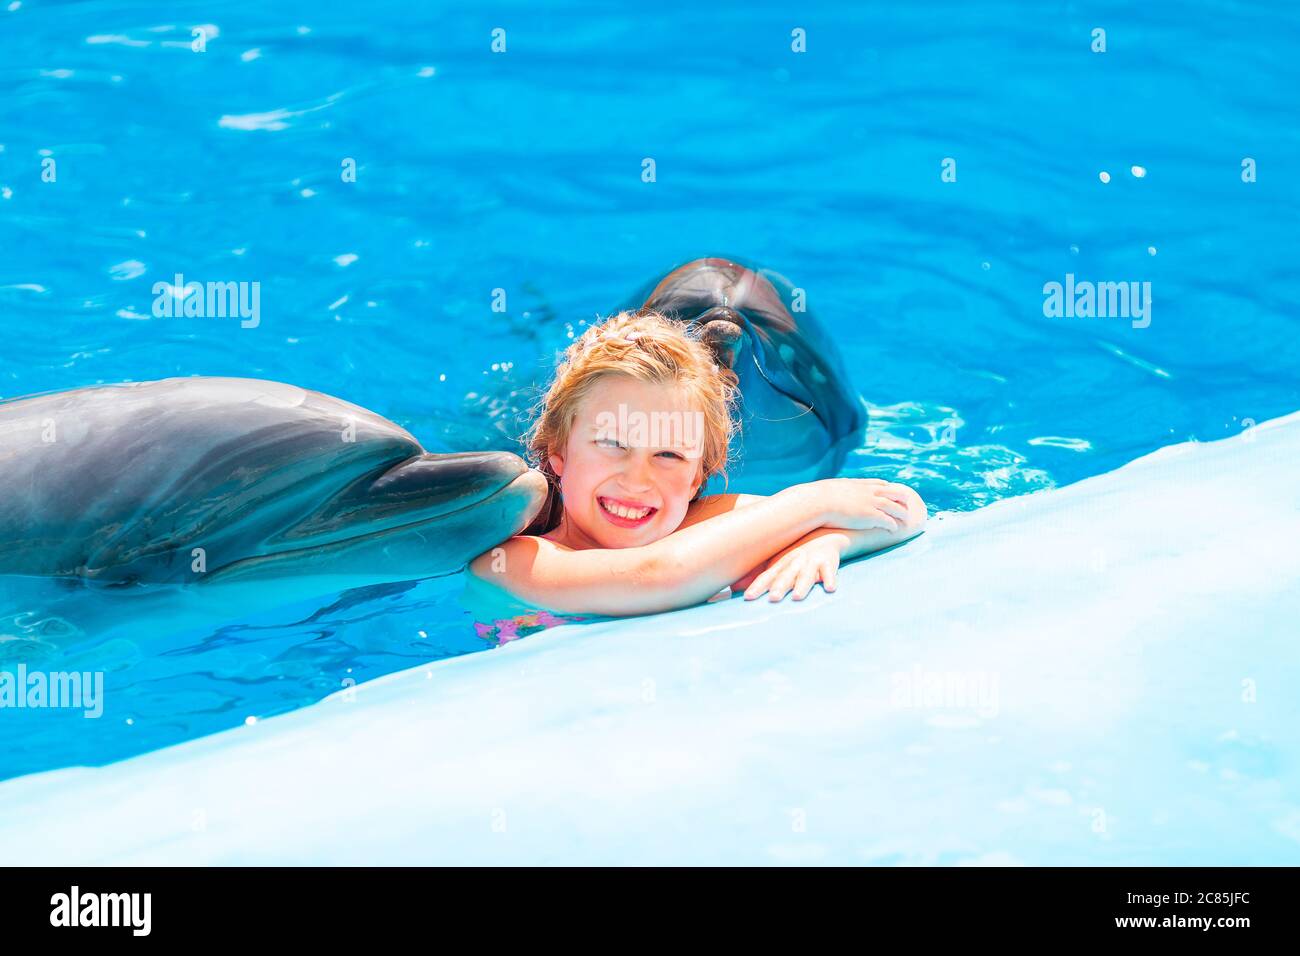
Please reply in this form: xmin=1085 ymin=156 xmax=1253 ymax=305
xmin=550 ymin=373 xmax=703 ymax=548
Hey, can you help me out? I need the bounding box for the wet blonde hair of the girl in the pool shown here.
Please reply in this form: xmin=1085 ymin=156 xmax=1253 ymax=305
xmin=524 ymin=310 xmax=740 ymax=535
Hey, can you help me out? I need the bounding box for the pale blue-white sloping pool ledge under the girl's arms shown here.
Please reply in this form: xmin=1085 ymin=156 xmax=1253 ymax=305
xmin=0 ymin=412 xmax=1300 ymax=865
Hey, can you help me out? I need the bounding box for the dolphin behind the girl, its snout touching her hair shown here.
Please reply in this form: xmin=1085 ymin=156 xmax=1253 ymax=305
xmin=627 ymin=259 xmax=867 ymax=494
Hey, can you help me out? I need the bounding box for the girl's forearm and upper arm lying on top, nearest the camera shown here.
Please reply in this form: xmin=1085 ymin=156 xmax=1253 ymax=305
xmin=469 ymin=479 xmax=906 ymax=617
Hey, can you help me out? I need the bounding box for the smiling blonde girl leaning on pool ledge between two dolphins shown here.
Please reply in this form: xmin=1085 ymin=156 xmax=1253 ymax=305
xmin=468 ymin=312 xmax=926 ymax=640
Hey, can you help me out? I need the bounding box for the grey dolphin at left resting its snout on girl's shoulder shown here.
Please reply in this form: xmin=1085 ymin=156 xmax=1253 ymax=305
xmin=0 ymin=377 xmax=546 ymax=591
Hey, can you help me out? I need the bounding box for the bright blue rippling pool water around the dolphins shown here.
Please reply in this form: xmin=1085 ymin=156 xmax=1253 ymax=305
xmin=0 ymin=0 xmax=1300 ymax=778
